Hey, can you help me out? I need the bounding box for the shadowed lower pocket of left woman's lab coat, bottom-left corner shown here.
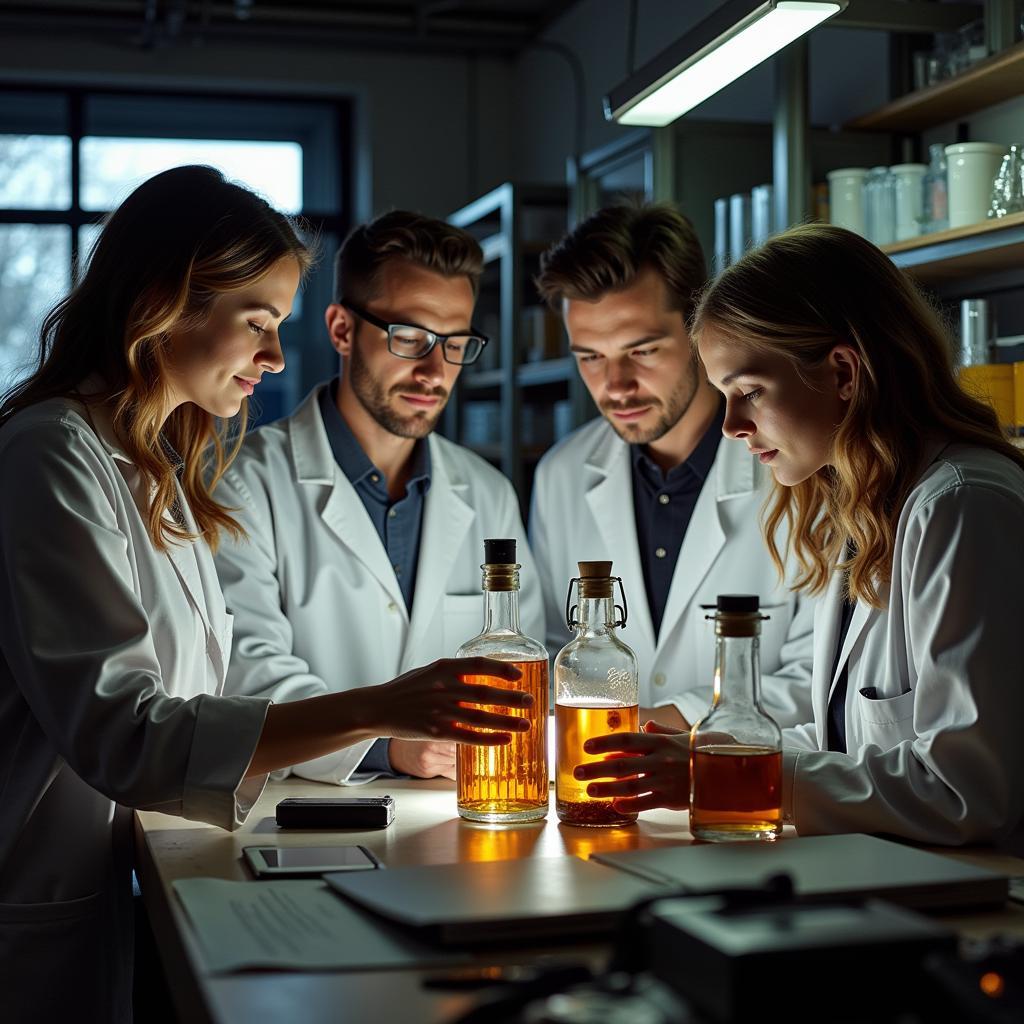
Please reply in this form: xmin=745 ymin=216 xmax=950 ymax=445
xmin=0 ymin=893 xmax=110 ymax=1024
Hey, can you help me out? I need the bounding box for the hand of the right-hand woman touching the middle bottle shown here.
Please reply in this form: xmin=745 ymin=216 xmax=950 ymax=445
xmin=572 ymin=721 xmax=690 ymax=814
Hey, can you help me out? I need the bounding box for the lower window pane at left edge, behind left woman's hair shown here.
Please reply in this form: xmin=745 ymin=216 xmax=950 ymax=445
xmin=0 ymin=224 xmax=71 ymax=390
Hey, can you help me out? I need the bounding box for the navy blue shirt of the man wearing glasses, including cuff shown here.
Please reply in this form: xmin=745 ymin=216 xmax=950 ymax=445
xmin=319 ymin=379 xmax=430 ymax=772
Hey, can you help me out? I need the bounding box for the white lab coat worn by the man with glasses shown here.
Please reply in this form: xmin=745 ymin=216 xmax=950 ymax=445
xmin=216 ymin=385 xmax=544 ymax=784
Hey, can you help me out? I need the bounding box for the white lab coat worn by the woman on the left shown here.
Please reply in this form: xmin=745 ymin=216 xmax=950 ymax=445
xmin=0 ymin=399 xmax=267 ymax=1024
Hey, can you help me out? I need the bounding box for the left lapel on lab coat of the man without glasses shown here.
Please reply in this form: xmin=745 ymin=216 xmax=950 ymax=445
xmin=574 ymin=436 xmax=654 ymax=650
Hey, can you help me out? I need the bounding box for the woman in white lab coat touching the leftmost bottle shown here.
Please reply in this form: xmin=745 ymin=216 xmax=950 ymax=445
xmin=0 ymin=167 xmax=528 ymax=1024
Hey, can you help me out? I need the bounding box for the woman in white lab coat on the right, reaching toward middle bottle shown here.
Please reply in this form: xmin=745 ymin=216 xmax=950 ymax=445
xmin=578 ymin=224 xmax=1024 ymax=844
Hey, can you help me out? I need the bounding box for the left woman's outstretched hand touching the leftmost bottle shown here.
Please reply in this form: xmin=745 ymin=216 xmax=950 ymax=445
xmin=362 ymin=657 xmax=534 ymax=746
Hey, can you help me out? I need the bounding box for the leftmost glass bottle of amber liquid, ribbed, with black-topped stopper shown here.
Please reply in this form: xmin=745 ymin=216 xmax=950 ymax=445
xmin=456 ymin=540 xmax=548 ymax=823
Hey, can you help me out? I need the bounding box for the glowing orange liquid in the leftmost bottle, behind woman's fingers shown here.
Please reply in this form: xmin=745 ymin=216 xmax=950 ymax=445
xmin=456 ymin=660 xmax=548 ymax=821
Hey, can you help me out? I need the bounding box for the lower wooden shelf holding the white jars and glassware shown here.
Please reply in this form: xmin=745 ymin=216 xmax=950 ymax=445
xmin=882 ymin=213 xmax=1024 ymax=285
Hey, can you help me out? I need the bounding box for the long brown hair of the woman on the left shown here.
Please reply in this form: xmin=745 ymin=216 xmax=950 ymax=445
xmin=0 ymin=166 xmax=312 ymax=549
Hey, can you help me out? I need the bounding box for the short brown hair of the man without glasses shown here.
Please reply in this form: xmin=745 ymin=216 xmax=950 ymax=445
xmin=536 ymin=203 xmax=708 ymax=321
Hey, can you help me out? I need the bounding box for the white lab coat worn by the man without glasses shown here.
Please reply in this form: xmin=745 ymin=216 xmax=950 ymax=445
xmin=529 ymin=419 xmax=814 ymax=725
